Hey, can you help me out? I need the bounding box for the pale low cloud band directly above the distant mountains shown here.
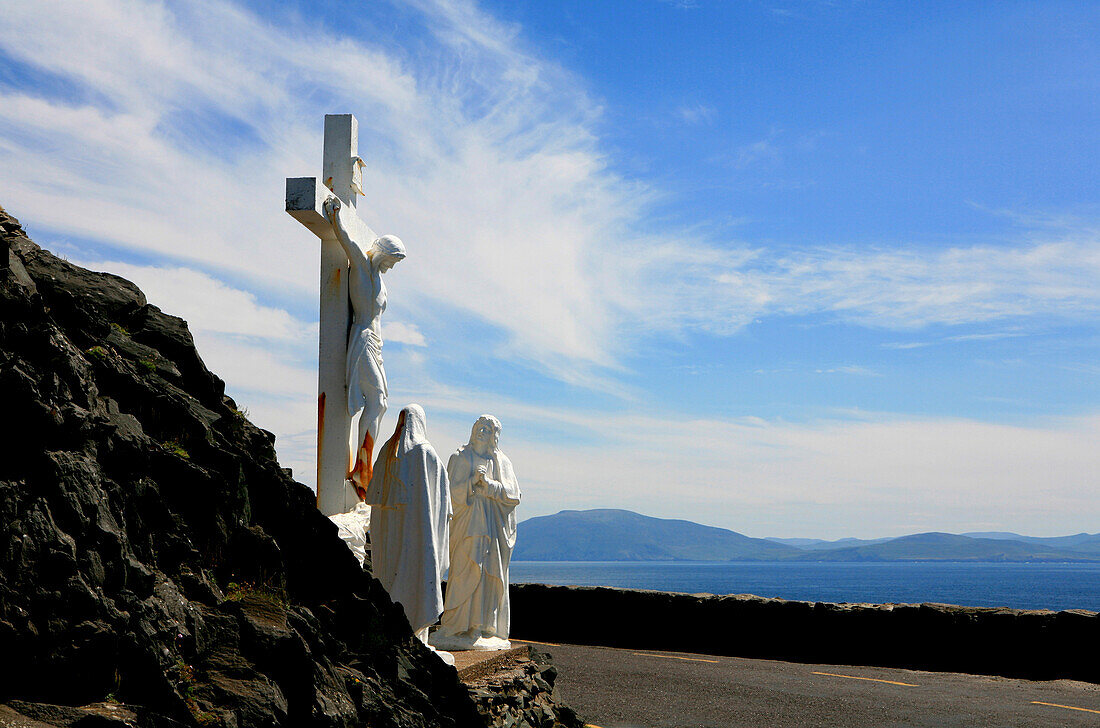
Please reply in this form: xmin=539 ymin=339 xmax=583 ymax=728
xmin=385 ymin=376 xmax=1100 ymax=538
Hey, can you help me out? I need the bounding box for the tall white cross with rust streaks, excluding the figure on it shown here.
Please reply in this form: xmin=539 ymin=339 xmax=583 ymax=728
xmin=286 ymin=113 xmax=377 ymax=516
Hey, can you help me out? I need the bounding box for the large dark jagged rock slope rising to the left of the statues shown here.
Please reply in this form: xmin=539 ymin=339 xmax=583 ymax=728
xmin=0 ymin=208 xmax=484 ymax=727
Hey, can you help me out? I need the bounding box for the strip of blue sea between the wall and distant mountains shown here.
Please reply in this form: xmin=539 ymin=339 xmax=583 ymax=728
xmin=510 ymin=561 xmax=1100 ymax=611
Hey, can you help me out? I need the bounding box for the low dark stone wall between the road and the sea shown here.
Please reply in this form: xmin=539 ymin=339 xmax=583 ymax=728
xmin=510 ymin=584 xmax=1100 ymax=683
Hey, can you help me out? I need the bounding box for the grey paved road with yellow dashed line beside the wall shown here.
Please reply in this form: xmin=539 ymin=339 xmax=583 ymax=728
xmin=513 ymin=640 xmax=1100 ymax=728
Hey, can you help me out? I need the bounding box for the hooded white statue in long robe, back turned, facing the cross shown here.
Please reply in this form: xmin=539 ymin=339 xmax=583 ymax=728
xmin=366 ymin=405 xmax=451 ymax=632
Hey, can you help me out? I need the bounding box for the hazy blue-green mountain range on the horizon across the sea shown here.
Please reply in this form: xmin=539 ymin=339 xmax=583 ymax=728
xmin=513 ymin=508 xmax=1100 ymax=562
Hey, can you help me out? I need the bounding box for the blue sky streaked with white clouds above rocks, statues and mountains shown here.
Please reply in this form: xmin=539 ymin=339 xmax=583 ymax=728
xmin=0 ymin=0 xmax=1100 ymax=538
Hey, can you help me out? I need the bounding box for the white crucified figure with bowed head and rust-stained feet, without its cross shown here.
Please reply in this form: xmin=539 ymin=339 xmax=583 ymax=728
xmin=325 ymin=197 xmax=405 ymax=500
